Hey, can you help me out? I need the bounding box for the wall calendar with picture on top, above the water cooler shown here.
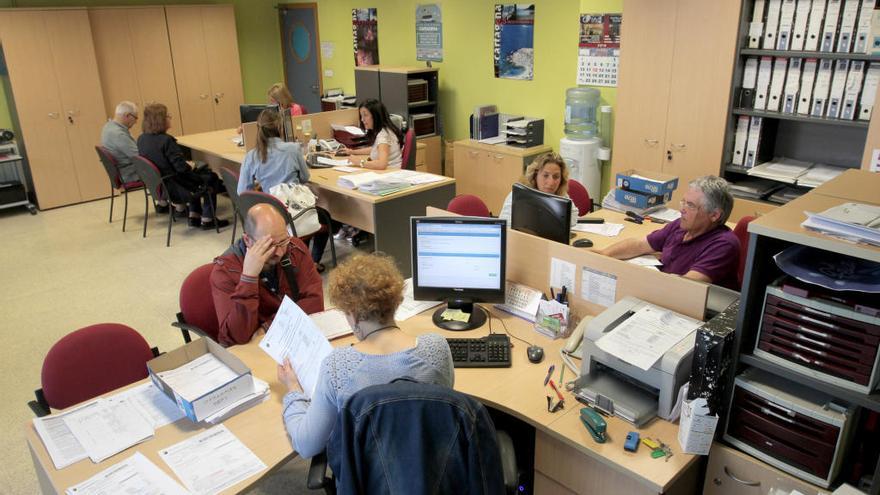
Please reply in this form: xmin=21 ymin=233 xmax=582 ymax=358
xmin=577 ymin=14 xmax=623 ymax=87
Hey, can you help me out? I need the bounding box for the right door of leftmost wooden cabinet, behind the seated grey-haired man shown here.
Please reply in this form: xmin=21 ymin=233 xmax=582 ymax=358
xmin=44 ymin=9 xmax=108 ymax=201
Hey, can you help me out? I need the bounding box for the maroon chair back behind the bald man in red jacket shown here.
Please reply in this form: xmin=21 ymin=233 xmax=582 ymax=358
xmin=171 ymin=263 xmax=220 ymax=343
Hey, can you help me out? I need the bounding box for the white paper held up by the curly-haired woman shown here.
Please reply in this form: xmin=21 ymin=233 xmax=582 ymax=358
xmin=260 ymin=296 xmax=333 ymax=397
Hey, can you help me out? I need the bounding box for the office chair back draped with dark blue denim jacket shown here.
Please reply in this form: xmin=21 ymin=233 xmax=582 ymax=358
xmin=308 ymin=379 xmax=517 ymax=495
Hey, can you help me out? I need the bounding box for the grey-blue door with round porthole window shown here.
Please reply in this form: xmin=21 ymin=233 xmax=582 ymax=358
xmin=278 ymin=3 xmax=323 ymax=113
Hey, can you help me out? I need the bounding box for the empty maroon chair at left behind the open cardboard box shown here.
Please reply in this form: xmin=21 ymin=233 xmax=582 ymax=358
xmin=28 ymin=323 xmax=159 ymax=416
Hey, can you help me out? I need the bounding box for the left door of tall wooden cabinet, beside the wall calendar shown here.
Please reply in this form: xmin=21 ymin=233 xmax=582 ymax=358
xmin=612 ymin=0 xmax=680 ymax=173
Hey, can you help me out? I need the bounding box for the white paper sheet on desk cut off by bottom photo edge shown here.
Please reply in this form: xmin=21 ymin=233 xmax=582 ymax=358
xmin=65 ymin=452 xmax=189 ymax=495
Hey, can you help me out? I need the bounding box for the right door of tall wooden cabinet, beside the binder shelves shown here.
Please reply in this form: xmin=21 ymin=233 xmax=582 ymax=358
xmin=662 ymin=0 xmax=741 ymax=204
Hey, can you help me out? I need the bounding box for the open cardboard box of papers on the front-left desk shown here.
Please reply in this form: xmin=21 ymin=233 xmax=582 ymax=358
xmin=147 ymin=338 xmax=254 ymax=422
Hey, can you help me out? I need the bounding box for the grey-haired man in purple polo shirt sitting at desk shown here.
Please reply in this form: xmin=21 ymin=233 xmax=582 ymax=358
xmin=596 ymin=175 xmax=740 ymax=290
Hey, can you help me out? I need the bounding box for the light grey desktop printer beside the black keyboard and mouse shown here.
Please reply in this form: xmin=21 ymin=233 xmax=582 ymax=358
xmin=575 ymin=297 xmax=701 ymax=428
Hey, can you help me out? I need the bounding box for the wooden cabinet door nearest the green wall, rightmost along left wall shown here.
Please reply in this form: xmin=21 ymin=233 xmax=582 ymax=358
xmin=201 ymin=5 xmax=244 ymax=129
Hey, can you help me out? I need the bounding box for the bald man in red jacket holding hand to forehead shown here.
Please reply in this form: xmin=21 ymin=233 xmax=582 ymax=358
xmin=211 ymin=204 xmax=324 ymax=346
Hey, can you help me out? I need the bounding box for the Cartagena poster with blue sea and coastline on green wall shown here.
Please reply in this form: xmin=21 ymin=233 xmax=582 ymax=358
xmin=494 ymin=3 xmax=535 ymax=81
